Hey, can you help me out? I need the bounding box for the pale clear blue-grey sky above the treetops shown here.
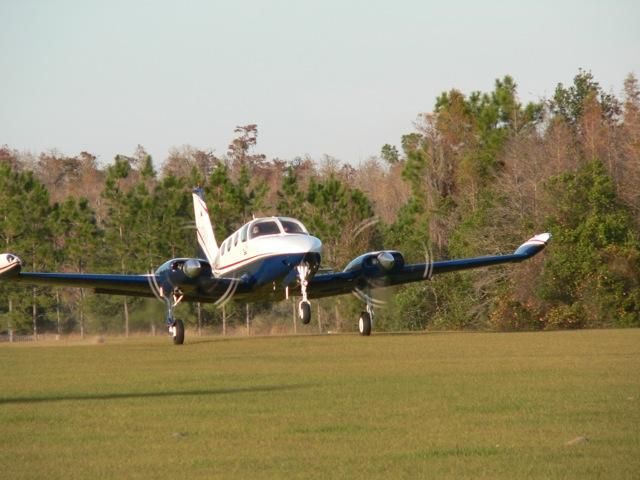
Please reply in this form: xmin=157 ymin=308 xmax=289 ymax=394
xmin=0 ymin=0 xmax=640 ymax=164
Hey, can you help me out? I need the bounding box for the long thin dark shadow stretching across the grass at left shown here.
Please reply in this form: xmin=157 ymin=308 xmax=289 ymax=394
xmin=0 ymin=384 xmax=313 ymax=405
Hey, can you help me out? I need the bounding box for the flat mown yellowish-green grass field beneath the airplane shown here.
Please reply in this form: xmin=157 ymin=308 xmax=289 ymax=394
xmin=0 ymin=330 xmax=640 ymax=479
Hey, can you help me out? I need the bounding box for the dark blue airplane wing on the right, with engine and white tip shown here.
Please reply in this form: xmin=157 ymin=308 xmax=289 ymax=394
xmin=309 ymin=233 xmax=551 ymax=298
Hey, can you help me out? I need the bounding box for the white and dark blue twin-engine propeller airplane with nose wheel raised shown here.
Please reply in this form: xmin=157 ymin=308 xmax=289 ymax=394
xmin=0 ymin=188 xmax=551 ymax=345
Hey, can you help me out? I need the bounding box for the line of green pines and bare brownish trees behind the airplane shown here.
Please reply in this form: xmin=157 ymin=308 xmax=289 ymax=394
xmin=0 ymin=70 xmax=640 ymax=335
